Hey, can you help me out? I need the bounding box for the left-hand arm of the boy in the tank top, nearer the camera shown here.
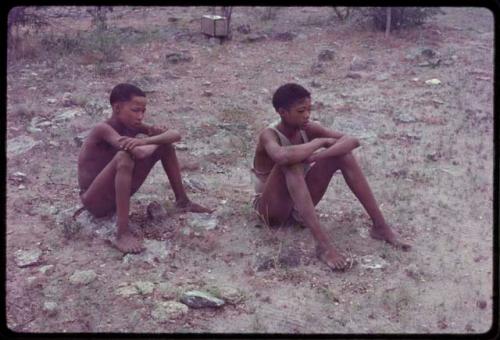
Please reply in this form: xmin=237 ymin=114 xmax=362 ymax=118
xmin=259 ymin=129 xmax=334 ymax=165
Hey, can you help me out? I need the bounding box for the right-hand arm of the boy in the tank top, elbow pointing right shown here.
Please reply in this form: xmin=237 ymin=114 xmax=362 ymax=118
xmin=306 ymin=123 xmax=359 ymax=163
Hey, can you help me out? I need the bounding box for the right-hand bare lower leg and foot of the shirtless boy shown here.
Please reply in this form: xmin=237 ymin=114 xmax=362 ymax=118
xmin=158 ymin=144 xmax=213 ymax=212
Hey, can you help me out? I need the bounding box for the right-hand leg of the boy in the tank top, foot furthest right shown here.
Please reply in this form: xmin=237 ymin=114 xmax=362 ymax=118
xmin=306 ymin=153 xmax=411 ymax=251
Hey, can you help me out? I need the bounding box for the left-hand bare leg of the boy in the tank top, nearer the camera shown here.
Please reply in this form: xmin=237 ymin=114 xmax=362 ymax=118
xmin=258 ymin=164 xmax=348 ymax=269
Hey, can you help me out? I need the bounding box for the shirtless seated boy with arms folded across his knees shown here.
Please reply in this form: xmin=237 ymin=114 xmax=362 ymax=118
xmin=78 ymin=84 xmax=211 ymax=253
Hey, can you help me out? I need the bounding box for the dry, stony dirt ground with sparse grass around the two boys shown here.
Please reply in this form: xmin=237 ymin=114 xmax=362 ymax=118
xmin=6 ymin=7 xmax=493 ymax=333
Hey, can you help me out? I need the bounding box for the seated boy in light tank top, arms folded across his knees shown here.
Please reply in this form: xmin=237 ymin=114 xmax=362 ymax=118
xmin=252 ymin=84 xmax=410 ymax=269
